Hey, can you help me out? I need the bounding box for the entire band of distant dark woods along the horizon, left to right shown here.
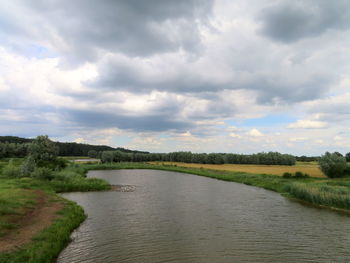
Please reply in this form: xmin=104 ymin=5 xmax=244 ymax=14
xmin=0 ymin=136 xmax=319 ymax=165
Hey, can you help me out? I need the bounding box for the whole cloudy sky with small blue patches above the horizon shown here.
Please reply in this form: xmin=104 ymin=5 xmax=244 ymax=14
xmin=0 ymin=0 xmax=350 ymax=155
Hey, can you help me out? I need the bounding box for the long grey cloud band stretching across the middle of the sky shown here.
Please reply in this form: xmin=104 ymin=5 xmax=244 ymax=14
xmin=85 ymin=51 xmax=337 ymax=105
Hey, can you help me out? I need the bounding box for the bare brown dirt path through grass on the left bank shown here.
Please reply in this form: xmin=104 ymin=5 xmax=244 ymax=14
xmin=0 ymin=190 xmax=63 ymax=252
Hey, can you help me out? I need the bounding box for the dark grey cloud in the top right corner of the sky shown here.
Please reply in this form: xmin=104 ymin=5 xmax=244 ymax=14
xmin=259 ymin=0 xmax=350 ymax=43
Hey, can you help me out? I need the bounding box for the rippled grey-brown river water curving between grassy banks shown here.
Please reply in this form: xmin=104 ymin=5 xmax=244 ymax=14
xmin=58 ymin=170 xmax=350 ymax=263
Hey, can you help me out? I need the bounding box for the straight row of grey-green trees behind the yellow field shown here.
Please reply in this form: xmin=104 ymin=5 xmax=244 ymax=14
xmin=100 ymin=151 xmax=296 ymax=165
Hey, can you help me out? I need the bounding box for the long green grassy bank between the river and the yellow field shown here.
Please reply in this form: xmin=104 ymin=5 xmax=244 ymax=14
xmin=84 ymin=163 xmax=350 ymax=210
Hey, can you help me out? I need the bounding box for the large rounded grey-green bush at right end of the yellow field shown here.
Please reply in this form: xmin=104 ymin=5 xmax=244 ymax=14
xmin=318 ymin=152 xmax=348 ymax=178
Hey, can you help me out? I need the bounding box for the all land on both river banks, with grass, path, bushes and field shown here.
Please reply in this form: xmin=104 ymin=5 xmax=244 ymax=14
xmin=0 ymin=136 xmax=350 ymax=262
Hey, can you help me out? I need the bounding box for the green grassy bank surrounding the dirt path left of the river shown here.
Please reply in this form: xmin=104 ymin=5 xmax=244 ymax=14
xmin=0 ymin=162 xmax=110 ymax=263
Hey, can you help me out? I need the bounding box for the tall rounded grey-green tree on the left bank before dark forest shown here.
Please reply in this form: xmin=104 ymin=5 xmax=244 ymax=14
xmin=28 ymin=135 xmax=58 ymax=163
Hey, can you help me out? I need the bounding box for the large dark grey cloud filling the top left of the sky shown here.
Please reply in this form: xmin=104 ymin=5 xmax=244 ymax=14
xmin=0 ymin=0 xmax=212 ymax=61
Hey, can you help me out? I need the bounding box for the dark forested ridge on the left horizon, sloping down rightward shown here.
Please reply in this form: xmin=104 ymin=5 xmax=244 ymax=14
xmin=0 ymin=136 xmax=148 ymax=158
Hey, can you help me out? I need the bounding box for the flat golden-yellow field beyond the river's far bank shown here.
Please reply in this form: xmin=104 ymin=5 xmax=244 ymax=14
xmin=152 ymin=162 xmax=325 ymax=177
